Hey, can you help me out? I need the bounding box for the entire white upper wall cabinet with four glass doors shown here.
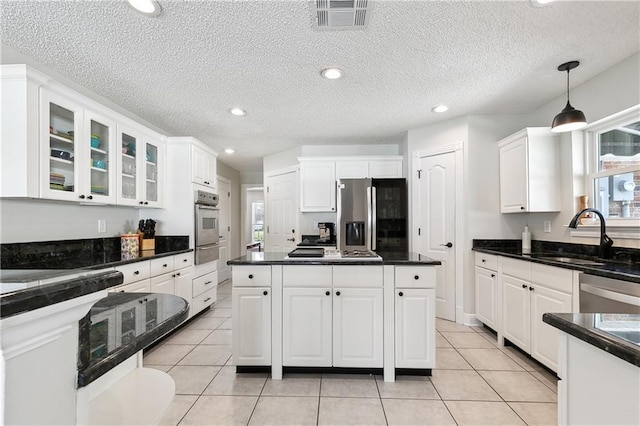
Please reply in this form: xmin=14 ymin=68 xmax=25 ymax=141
xmin=0 ymin=65 xmax=164 ymax=207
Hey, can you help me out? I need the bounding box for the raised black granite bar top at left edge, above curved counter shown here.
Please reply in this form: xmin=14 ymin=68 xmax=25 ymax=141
xmin=0 ymin=271 xmax=123 ymax=318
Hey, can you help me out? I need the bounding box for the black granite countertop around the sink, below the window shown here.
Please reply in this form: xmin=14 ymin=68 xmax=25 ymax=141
xmin=473 ymin=240 xmax=640 ymax=283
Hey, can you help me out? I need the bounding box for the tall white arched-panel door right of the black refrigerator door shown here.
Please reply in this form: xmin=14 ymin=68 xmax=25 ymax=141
xmin=418 ymin=152 xmax=456 ymax=321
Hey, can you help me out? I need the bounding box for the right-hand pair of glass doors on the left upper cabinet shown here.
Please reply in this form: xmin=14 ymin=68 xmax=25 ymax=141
xmin=117 ymin=125 xmax=164 ymax=207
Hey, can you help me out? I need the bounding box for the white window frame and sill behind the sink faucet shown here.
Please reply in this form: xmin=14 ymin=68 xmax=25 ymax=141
xmin=571 ymin=104 xmax=640 ymax=240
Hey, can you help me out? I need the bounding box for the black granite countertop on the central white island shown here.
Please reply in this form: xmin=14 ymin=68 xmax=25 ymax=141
xmin=227 ymin=252 xmax=441 ymax=266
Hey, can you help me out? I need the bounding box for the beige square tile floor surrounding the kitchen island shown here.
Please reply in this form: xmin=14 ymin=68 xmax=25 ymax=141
xmin=144 ymin=282 xmax=557 ymax=425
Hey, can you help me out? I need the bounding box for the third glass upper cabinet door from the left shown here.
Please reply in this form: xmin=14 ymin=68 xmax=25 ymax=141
xmin=118 ymin=129 xmax=144 ymax=206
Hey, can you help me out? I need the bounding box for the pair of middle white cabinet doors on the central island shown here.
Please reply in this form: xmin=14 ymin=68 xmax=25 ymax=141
xmin=282 ymin=287 xmax=383 ymax=368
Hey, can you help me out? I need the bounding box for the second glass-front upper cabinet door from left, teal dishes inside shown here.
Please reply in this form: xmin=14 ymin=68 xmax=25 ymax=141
xmin=80 ymin=111 xmax=117 ymax=204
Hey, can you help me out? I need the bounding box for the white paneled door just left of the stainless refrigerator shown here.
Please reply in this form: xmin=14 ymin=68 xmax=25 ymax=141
xmin=265 ymin=171 xmax=298 ymax=253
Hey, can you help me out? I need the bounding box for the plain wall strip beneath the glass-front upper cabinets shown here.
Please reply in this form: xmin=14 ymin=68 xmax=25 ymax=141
xmin=0 ymin=199 xmax=138 ymax=244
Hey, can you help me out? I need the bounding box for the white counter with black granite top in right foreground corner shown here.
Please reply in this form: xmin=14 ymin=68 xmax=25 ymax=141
xmin=543 ymin=313 xmax=640 ymax=425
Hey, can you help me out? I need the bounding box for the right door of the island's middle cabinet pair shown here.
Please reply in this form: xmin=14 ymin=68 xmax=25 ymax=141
xmin=333 ymin=288 xmax=383 ymax=368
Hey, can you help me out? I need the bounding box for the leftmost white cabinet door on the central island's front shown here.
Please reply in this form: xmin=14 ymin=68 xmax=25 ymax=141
xmin=232 ymin=287 xmax=271 ymax=366
